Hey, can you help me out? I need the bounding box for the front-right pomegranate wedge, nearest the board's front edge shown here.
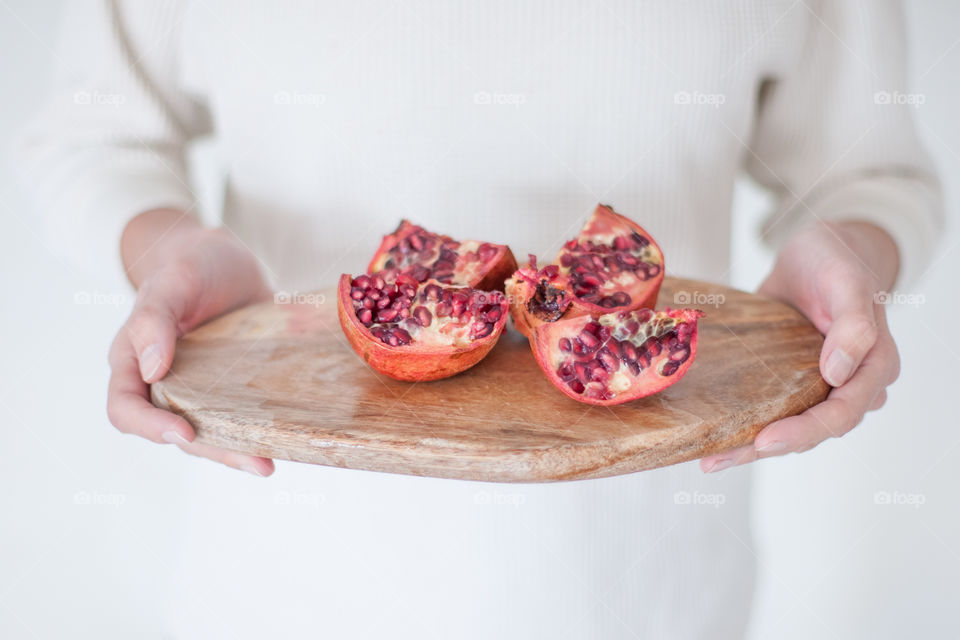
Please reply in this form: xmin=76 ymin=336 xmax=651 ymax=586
xmin=532 ymin=309 xmax=704 ymax=405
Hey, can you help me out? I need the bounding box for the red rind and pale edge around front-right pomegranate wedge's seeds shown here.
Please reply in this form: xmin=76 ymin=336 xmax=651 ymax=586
xmin=531 ymin=308 xmax=705 ymax=406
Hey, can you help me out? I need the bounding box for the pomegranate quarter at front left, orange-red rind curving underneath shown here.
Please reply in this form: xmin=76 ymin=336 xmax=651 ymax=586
xmin=337 ymin=274 xmax=507 ymax=382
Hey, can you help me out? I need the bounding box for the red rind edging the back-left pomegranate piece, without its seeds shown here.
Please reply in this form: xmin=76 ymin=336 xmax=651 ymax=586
xmin=367 ymin=220 xmax=517 ymax=291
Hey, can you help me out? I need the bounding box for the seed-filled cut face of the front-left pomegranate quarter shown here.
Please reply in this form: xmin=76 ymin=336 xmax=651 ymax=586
xmin=350 ymin=274 xmax=507 ymax=347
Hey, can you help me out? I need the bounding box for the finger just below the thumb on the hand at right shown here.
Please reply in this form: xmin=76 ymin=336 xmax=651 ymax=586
xmin=754 ymin=338 xmax=895 ymax=458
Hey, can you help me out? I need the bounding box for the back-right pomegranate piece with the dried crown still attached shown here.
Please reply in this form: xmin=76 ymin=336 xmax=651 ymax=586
xmin=506 ymin=204 xmax=664 ymax=337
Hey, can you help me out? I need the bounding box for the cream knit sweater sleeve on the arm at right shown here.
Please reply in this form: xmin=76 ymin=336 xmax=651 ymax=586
xmin=747 ymin=0 xmax=944 ymax=287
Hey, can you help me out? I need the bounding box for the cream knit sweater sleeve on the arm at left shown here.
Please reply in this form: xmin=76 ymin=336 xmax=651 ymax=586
xmin=12 ymin=0 xmax=209 ymax=280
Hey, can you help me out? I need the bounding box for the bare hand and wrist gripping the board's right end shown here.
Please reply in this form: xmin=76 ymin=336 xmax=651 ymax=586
xmin=700 ymin=222 xmax=900 ymax=472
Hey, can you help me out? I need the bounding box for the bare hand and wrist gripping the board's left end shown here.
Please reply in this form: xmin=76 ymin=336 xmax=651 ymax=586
xmin=107 ymin=210 xmax=273 ymax=476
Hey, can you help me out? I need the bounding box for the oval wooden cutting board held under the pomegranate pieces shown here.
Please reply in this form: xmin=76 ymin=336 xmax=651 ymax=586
xmin=152 ymin=278 xmax=829 ymax=482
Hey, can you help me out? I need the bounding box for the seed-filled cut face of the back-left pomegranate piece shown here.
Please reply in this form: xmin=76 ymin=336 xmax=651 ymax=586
xmin=377 ymin=225 xmax=500 ymax=285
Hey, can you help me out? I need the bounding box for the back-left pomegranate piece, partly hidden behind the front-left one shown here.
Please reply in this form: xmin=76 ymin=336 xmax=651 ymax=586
xmin=367 ymin=220 xmax=517 ymax=291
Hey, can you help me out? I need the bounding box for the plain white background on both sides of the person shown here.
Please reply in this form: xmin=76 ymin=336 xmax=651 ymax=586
xmin=0 ymin=0 xmax=960 ymax=638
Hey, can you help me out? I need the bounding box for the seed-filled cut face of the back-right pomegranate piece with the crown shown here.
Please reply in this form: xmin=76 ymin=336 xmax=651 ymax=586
xmin=557 ymin=229 xmax=663 ymax=309
